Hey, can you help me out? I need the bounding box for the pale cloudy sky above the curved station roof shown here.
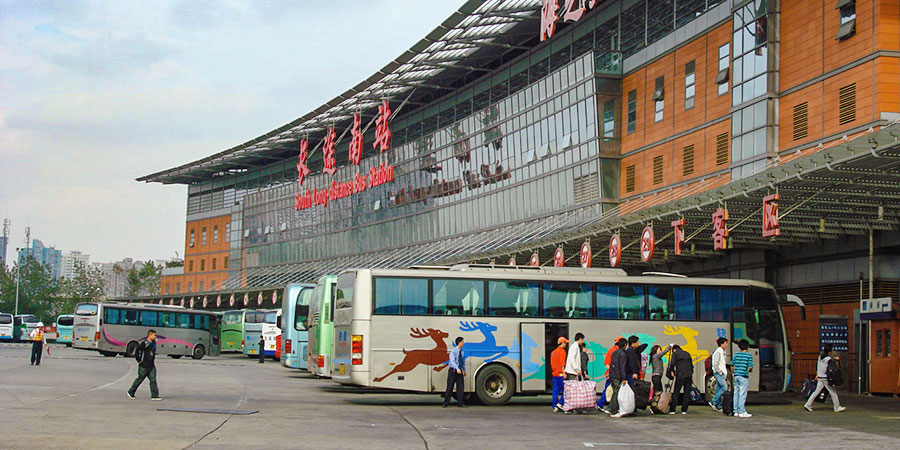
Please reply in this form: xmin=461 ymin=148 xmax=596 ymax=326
xmin=0 ymin=0 xmax=462 ymax=262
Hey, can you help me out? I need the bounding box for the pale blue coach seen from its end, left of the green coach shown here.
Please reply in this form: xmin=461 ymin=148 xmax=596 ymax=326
xmin=278 ymin=283 xmax=316 ymax=369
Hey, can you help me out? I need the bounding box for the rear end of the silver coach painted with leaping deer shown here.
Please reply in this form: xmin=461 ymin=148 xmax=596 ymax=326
xmin=331 ymin=270 xmax=372 ymax=386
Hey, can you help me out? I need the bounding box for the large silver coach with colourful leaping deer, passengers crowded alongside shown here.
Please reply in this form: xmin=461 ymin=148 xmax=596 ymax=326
xmin=332 ymin=265 xmax=790 ymax=405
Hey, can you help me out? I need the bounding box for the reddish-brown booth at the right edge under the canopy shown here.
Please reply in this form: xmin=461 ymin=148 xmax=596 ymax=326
xmin=869 ymin=311 xmax=900 ymax=395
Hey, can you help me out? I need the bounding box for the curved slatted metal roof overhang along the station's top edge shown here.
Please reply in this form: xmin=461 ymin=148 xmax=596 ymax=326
xmin=137 ymin=0 xmax=541 ymax=184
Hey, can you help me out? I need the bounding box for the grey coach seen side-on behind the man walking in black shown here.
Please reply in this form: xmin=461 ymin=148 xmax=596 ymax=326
xmin=72 ymin=303 xmax=220 ymax=359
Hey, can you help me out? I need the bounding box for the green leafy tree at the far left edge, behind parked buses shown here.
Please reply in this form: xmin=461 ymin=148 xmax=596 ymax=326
xmin=0 ymin=257 xmax=62 ymax=324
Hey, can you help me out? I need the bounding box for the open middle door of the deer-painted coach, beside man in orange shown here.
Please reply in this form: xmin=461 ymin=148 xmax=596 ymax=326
xmin=519 ymin=323 xmax=569 ymax=392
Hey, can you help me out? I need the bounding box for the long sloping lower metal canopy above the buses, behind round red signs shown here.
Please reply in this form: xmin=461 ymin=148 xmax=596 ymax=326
xmin=224 ymin=122 xmax=900 ymax=288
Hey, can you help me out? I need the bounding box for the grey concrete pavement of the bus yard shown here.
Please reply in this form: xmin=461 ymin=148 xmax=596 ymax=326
xmin=0 ymin=345 xmax=900 ymax=450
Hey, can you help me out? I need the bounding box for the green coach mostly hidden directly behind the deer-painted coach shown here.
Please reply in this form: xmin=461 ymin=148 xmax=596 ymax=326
xmin=306 ymin=275 xmax=337 ymax=377
